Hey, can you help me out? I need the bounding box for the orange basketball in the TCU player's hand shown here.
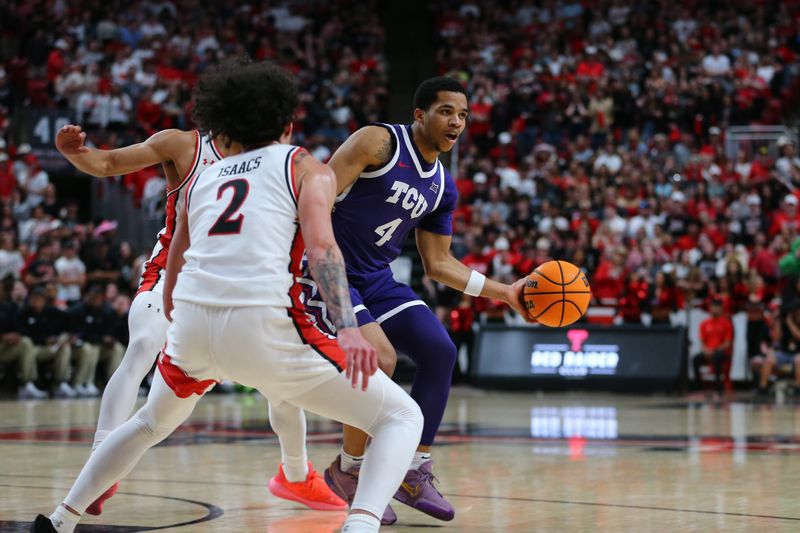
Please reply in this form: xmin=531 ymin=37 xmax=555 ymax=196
xmin=523 ymin=261 xmax=592 ymax=328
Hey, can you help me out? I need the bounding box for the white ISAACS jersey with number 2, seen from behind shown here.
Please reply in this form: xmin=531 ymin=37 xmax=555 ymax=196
xmin=173 ymin=144 xmax=305 ymax=307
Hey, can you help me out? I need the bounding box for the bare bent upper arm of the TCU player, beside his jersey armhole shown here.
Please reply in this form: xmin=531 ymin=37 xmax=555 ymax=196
xmin=328 ymin=126 xmax=394 ymax=194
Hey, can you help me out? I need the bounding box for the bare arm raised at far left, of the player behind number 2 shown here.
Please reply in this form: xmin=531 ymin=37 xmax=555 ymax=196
xmin=56 ymin=124 xmax=188 ymax=178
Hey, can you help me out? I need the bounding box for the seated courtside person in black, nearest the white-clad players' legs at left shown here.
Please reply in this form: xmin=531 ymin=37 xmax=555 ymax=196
xmin=69 ymin=285 xmax=125 ymax=396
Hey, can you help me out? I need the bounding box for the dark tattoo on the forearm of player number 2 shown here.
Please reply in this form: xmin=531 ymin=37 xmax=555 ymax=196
xmin=308 ymin=245 xmax=358 ymax=330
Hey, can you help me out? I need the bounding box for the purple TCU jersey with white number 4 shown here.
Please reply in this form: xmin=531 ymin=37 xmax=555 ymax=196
xmin=332 ymin=124 xmax=458 ymax=276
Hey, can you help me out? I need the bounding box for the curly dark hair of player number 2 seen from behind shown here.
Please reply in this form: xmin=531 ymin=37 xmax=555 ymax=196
xmin=194 ymin=59 xmax=299 ymax=147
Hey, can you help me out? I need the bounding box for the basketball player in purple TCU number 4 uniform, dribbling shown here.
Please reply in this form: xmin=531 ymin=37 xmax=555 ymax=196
xmin=294 ymin=77 xmax=527 ymax=524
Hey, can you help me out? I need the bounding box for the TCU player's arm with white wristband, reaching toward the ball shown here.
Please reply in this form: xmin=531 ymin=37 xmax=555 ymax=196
xmin=416 ymin=228 xmax=530 ymax=322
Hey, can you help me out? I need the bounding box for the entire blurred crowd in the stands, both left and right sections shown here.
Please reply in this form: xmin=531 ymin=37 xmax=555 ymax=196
xmin=0 ymin=0 xmax=800 ymax=394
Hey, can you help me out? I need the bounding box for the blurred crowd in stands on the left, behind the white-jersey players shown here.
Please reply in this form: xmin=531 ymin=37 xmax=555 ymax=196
xmin=0 ymin=0 xmax=386 ymax=398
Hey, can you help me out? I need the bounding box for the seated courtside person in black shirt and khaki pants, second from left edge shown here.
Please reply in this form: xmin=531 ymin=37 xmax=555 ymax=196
xmin=20 ymin=287 xmax=76 ymax=398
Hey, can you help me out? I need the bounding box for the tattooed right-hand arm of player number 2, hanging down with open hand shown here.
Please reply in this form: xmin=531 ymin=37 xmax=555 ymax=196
xmin=296 ymin=151 xmax=378 ymax=390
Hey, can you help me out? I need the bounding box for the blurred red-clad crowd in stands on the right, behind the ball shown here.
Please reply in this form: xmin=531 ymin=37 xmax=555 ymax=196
xmin=424 ymin=0 xmax=800 ymax=385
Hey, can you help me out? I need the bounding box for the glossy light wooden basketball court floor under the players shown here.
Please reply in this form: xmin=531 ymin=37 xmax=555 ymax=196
xmin=0 ymin=389 xmax=800 ymax=533
